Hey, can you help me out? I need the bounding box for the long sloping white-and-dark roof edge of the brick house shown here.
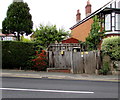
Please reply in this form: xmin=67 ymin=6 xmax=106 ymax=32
xmin=70 ymin=0 xmax=120 ymax=30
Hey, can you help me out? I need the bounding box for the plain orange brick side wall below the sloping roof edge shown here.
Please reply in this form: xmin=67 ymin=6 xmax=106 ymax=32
xmin=71 ymin=18 xmax=93 ymax=42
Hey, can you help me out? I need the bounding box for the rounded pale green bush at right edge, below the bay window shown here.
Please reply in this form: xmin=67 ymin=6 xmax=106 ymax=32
xmin=102 ymin=36 xmax=120 ymax=60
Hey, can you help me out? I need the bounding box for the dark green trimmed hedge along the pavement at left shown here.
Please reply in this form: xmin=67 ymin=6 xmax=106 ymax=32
xmin=2 ymin=41 xmax=35 ymax=69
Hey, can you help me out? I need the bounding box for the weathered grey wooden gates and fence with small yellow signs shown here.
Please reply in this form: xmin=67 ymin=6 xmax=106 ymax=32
xmin=48 ymin=44 xmax=101 ymax=74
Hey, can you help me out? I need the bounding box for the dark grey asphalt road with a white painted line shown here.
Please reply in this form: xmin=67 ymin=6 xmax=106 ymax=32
xmin=0 ymin=77 xmax=118 ymax=98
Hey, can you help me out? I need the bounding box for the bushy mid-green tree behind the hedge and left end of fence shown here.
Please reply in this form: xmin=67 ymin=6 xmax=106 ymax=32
xmin=33 ymin=24 xmax=68 ymax=48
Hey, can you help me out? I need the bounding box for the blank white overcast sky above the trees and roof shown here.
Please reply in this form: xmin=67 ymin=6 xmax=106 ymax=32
xmin=0 ymin=0 xmax=111 ymax=31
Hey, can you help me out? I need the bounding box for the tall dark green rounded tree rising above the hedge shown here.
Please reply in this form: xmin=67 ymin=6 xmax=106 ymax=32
xmin=2 ymin=2 xmax=33 ymax=40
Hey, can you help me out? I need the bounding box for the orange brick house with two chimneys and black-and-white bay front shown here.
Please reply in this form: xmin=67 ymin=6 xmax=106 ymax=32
xmin=70 ymin=0 xmax=120 ymax=42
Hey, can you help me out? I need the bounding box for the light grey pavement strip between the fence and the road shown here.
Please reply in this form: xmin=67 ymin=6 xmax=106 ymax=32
xmin=0 ymin=70 xmax=120 ymax=82
